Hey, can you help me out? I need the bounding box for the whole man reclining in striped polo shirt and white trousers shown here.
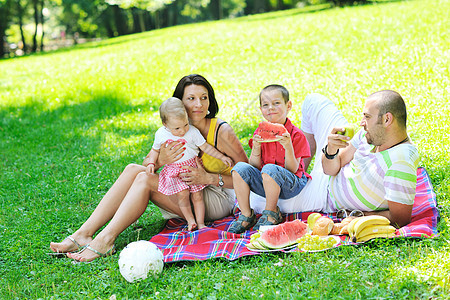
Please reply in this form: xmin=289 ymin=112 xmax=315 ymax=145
xmin=251 ymin=90 xmax=419 ymax=227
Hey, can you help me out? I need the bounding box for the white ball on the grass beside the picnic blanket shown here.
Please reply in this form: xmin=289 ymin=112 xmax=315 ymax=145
xmin=119 ymin=241 xmax=164 ymax=282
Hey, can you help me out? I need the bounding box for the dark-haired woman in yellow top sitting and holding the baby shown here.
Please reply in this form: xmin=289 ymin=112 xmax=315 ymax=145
xmin=50 ymin=74 xmax=247 ymax=261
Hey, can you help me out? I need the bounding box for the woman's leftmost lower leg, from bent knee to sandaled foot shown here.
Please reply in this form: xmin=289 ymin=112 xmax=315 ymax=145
xmin=50 ymin=164 xmax=145 ymax=253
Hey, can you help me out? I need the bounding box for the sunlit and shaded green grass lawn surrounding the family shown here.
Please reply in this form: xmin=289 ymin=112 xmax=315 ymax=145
xmin=0 ymin=0 xmax=450 ymax=299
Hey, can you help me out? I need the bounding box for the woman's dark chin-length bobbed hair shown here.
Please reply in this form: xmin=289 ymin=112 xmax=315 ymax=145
xmin=173 ymin=74 xmax=219 ymax=119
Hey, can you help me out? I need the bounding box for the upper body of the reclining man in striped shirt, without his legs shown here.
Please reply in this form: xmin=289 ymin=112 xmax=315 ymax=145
xmin=322 ymin=90 xmax=419 ymax=226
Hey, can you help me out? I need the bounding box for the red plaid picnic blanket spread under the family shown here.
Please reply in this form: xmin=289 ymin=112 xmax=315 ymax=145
xmin=150 ymin=168 xmax=439 ymax=263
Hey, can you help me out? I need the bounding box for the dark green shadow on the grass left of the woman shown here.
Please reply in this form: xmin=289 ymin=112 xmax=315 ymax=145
xmin=0 ymin=95 xmax=162 ymax=251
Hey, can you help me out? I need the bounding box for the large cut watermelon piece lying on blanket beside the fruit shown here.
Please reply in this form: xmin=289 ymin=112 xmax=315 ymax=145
xmin=258 ymin=220 xmax=308 ymax=249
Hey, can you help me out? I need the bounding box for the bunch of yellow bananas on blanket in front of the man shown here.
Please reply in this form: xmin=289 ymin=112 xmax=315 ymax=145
xmin=348 ymin=216 xmax=395 ymax=243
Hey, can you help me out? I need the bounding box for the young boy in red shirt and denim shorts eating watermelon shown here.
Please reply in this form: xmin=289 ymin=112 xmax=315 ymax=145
xmin=228 ymin=84 xmax=311 ymax=233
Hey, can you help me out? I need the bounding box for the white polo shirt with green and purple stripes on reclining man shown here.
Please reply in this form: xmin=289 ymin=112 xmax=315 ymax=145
xmin=328 ymin=130 xmax=419 ymax=211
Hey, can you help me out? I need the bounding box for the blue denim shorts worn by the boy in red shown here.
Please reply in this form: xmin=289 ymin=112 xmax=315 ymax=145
xmin=231 ymin=162 xmax=308 ymax=199
